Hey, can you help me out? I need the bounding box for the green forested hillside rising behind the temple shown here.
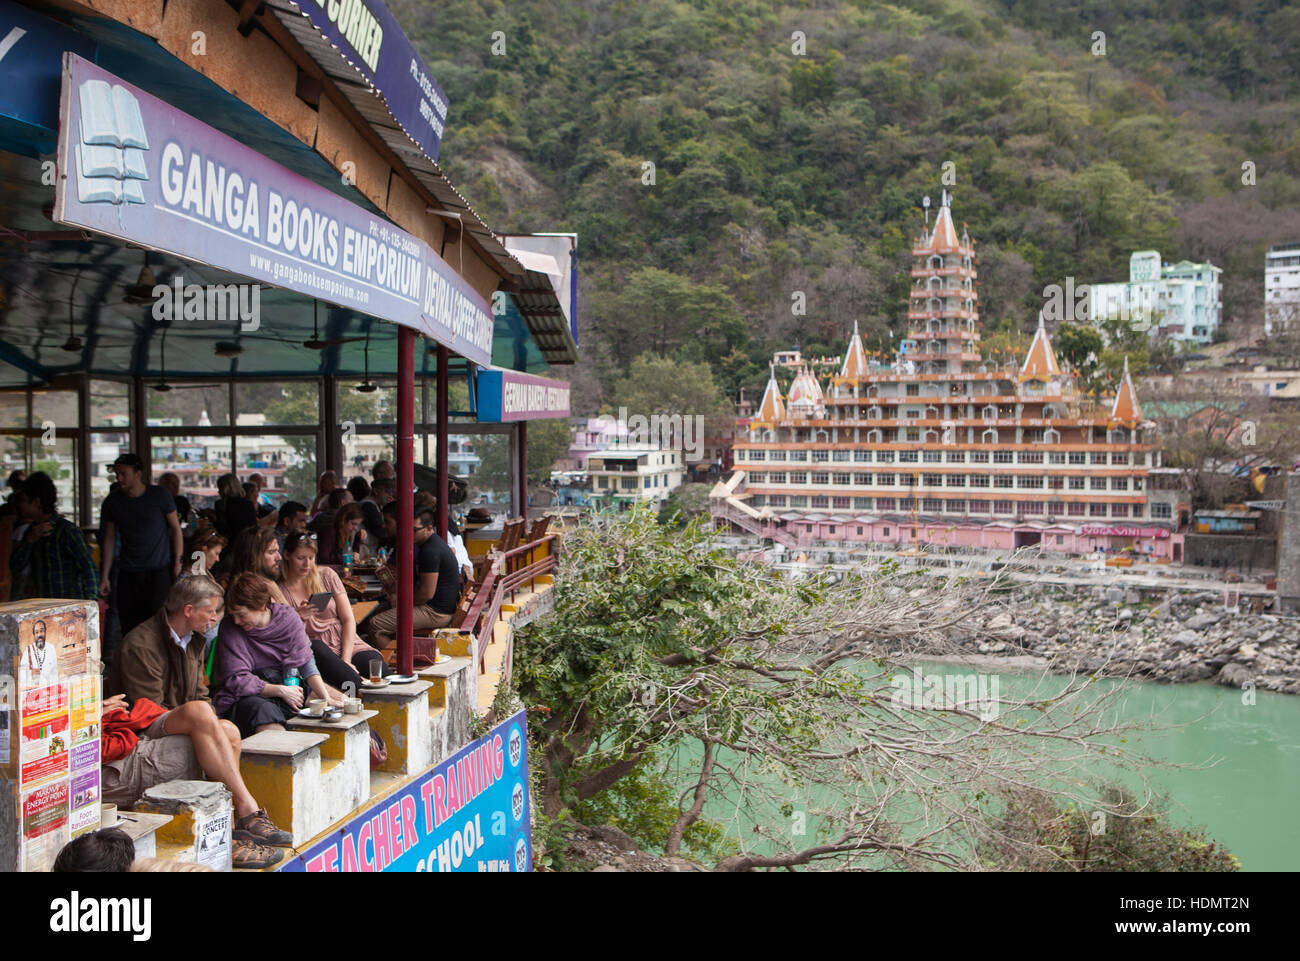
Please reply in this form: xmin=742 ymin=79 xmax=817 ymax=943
xmin=390 ymin=0 xmax=1300 ymax=412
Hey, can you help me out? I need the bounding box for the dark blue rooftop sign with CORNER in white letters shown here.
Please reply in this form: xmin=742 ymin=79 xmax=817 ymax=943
xmin=296 ymin=0 xmax=447 ymax=160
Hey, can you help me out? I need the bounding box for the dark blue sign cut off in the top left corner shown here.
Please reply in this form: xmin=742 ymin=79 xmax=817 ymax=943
xmin=0 ymin=0 xmax=95 ymax=153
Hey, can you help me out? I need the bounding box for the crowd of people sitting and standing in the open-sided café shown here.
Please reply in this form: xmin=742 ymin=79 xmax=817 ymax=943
xmin=0 ymin=454 xmax=483 ymax=870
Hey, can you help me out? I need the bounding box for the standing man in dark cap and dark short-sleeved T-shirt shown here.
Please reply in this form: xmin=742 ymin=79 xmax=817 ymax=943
xmin=99 ymin=454 xmax=185 ymax=637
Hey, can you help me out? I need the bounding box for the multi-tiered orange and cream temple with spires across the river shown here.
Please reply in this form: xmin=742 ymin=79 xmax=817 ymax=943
xmin=712 ymin=194 xmax=1182 ymax=560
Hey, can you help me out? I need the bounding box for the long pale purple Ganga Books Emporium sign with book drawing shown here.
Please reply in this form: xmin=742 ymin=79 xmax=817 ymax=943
xmin=55 ymin=53 xmax=494 ymax=364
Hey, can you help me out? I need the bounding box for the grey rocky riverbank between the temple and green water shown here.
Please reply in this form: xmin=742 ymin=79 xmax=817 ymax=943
xmin=917 ymin=585 xmax=1300 ymax=694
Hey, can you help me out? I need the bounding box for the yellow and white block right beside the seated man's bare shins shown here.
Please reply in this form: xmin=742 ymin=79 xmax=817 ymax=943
xmin=239 ymin=733 xmax=330 ymax=845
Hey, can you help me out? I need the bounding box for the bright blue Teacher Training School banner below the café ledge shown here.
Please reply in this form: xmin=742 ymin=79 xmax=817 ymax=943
xmin=280 ymin=711 xmax=533 ymax=873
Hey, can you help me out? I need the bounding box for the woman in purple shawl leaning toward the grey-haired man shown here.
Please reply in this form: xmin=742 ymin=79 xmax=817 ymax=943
xmin=212 ymin=572 xmax=343 ymax=737
